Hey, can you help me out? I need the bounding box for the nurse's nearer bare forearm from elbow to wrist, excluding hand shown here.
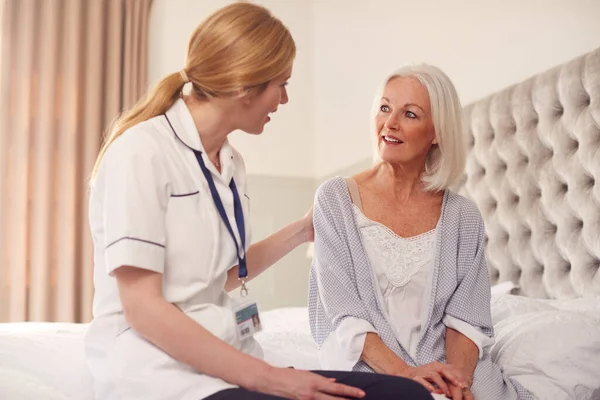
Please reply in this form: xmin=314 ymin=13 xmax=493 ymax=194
xmin=126 ymin=297 xmax=272 ymax=390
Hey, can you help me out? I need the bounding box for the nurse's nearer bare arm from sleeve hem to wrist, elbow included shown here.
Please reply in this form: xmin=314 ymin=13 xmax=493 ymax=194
xmin=116 ymin=267 xmax=272 ymax=390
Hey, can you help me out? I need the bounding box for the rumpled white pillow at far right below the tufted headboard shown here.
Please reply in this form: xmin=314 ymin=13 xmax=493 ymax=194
xmin=491 ymin=309 xmax=600 ymax=400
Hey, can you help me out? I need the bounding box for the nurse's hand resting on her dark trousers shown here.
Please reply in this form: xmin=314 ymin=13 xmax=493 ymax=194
xmin=257 ymin=368 xmax=365 ymax=400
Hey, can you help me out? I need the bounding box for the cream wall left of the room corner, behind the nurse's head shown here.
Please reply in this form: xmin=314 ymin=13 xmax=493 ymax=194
xmin=148 ymin=0 xmax=316 ymax=178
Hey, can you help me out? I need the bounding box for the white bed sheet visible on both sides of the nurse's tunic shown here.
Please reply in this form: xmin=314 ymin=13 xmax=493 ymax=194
xmin=0 ymin=308 xmax=319 ymax=400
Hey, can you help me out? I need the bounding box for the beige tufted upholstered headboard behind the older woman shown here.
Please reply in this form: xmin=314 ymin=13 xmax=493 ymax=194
xmin=459 ymin=49 xmax=600 ymax=298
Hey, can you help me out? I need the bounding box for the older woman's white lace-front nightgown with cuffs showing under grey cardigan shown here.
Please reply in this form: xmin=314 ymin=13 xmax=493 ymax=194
xmin=324 ymin=205 xmax=494 ymax=366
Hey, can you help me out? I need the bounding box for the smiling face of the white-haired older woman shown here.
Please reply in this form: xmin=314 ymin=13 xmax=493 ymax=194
xmin=375 ymin=77 xmax=437 ymax=168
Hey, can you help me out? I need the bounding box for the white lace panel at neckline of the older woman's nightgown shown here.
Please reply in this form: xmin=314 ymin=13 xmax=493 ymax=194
xmin=353 ymin=206 xmax=436 ymax=287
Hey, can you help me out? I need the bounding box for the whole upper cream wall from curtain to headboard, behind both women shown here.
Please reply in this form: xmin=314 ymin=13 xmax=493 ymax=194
xmin=149 ymin=0 xmax=600 ymax=178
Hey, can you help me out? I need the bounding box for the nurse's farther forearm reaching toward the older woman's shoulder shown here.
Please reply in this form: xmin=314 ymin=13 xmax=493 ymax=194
xmin=225 ymin=220 xmax=309 ymax=291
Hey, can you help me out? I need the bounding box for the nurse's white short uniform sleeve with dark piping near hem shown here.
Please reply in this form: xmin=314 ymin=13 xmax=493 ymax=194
xmin=99 ymin=132 xmax=169 ymax=275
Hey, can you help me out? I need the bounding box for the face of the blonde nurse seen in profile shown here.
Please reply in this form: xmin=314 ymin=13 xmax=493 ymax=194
xmin=240 ymin=67 xmax=292 ymax=135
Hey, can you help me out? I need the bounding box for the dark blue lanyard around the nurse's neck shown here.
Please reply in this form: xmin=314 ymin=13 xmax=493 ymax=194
xmin=164 ymin=114 xmax=248 ymax=296
